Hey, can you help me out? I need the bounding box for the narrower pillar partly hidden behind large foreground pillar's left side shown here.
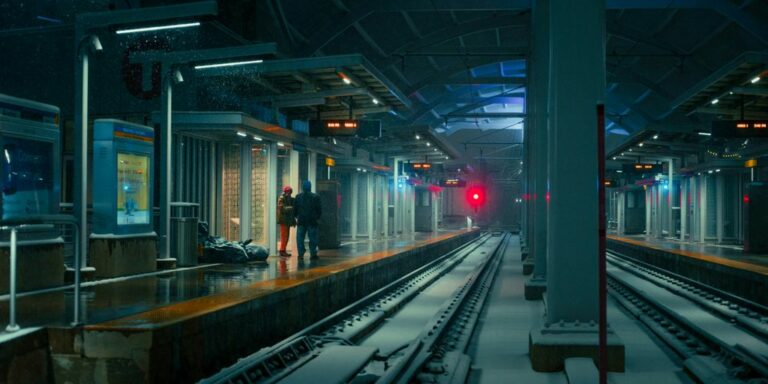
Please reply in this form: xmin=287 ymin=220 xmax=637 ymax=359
xmin=523 ymin=0 xmax=550 ymax=300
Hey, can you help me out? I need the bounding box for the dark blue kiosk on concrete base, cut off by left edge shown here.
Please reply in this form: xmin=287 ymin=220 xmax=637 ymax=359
xmin=0 ymin=94 xmax=64 ymax=293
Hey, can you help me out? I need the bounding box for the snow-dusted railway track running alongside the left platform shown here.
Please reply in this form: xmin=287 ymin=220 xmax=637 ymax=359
xmin=201 ymin=232 xmax=510 ymax=384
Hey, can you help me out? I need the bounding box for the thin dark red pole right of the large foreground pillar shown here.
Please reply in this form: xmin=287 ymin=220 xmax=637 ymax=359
xmin=597 ymin=104 xmax=608 ymax=384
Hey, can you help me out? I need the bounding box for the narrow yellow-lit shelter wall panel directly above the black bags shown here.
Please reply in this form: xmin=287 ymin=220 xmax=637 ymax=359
xmin=221 ymin=143 xmax=240 ymax=240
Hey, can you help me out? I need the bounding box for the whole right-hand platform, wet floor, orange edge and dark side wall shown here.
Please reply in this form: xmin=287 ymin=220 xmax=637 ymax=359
xmin=607 ymin=235 xmax=768 ymax=305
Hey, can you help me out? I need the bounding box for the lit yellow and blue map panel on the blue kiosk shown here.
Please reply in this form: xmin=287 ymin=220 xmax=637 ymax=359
xmin=117 ymin=152 xmax=151 ymax=225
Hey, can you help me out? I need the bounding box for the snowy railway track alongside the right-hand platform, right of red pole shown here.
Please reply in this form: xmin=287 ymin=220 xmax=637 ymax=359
xmin=607 ymin=251 xmax=768 ymax=384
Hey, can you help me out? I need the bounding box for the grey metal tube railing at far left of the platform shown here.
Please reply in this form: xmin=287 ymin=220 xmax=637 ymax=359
xmin=0 ymin=215 xmax=82 ymax=332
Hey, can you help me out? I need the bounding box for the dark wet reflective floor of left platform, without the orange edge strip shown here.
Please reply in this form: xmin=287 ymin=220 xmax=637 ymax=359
xmin=0 ymin=228 xmax=460 ymax=327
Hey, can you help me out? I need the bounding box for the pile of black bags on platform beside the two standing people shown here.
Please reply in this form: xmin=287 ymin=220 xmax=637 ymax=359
xmin=197 ymin=222 xmax=269 ymax=263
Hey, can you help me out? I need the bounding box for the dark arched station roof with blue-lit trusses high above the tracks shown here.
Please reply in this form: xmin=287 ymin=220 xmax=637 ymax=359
xmin=0 ymin=0 xmax=768 ymax=177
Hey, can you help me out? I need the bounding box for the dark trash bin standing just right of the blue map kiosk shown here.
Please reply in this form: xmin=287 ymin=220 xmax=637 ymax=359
xmin=170 ymin=202 xmax=200 ymax=267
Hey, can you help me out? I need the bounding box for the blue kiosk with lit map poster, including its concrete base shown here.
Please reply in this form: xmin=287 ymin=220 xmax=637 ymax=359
xmin=90 ymin=119 xmax=157 ymax=277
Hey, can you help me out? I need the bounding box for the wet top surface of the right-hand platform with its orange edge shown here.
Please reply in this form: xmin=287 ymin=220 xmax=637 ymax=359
xmin=608 ymin=235 xmax=768 ymax=276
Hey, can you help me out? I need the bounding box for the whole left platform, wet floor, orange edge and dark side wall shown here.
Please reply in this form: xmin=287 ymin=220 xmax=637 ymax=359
xmin=0 ymin=230 xmax=479 ymax=383
